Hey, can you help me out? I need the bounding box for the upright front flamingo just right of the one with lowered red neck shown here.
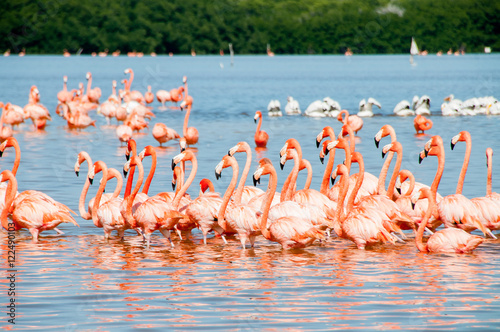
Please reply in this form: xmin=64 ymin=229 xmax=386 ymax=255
xmin=215 ymin=155 xmax=261 ymax=249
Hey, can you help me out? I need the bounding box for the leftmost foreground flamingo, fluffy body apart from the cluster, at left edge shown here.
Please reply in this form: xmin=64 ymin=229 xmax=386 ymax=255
xmin=0 ymin=170 xmax=80 ymax=243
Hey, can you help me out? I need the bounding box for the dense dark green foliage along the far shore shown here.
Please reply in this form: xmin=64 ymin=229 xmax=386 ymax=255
xmin=0 ymin=0 xmax=500 ymax=54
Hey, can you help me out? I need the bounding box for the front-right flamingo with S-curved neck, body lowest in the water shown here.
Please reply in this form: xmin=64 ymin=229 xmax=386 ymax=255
xmin=411 ymin=188 xmax=485 ymax=254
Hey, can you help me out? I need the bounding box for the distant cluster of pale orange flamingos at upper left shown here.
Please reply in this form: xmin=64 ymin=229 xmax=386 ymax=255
xmin=0 ymin=68 xmax=198 ymax=146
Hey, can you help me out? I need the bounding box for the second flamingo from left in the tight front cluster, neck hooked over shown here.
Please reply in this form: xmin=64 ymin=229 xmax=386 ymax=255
xmin=88 ymin=160 xmax=129 ymax=240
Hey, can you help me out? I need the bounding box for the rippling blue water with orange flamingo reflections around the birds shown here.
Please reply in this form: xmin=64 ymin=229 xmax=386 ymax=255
xmin=0 ymin=54 xmax=500 ymax=331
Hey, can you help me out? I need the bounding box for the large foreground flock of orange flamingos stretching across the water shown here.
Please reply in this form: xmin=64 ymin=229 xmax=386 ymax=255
xmin=0 ymin=97 xmax=500 ymax=253
